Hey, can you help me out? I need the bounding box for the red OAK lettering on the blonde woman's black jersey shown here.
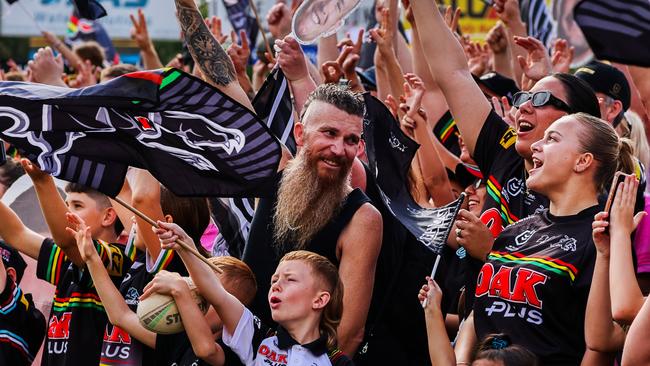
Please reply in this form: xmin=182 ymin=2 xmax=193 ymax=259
xmin=476 ymin=263 xmax=548 ymax=309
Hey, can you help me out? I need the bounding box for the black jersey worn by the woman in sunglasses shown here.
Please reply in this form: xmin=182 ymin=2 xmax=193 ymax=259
xmin=473 ymin=111 xmax=549 ymax=233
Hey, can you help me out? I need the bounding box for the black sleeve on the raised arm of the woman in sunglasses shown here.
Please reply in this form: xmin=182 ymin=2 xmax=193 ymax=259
xmin=472 ymin=111 xmax=518 ymax=176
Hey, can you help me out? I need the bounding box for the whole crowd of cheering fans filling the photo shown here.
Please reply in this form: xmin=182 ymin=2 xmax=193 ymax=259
xmin=0 ymin=0 xmax=650 ymax=366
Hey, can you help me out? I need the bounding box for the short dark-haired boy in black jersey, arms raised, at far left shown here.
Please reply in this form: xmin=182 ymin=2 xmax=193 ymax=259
xmin=0 ymin=160 xmax=131 ymax=366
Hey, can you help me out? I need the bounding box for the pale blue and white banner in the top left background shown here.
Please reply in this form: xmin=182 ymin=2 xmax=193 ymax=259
xmin=0 ymin=0 xmax=180 ymax=40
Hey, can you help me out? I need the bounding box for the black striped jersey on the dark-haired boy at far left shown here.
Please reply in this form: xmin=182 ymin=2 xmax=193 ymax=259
xmin=36 ymin=238 xmax=131 ymax=366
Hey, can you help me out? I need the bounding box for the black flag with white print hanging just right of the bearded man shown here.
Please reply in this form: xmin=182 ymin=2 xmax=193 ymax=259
xmin=363 ymin=94 xmax=464 ymax=254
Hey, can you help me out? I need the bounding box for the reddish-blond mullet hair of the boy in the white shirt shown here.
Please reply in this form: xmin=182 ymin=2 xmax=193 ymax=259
xmin=280 ymin=250 xmax=343 ymax=349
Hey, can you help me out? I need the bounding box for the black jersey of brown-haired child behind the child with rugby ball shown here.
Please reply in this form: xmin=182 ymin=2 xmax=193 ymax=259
xmin=100 ymin=229 xmax=187 ymax=366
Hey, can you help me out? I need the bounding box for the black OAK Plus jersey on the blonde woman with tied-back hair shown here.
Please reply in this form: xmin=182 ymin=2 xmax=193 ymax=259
xmin=474 ymin=205 xmax=602 ymax=365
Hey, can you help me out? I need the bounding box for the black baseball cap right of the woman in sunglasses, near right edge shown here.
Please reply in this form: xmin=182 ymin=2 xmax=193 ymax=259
xmin=574 ymin=61 xmax=632 ymax=111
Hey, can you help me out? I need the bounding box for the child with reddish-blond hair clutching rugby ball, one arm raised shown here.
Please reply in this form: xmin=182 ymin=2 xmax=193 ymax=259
xmin=68 ymin=214 xmax=256 ymax=366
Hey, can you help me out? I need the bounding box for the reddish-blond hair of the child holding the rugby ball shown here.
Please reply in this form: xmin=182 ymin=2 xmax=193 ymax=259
xmin=208 ymin=256 xmax=257 ymax=306
